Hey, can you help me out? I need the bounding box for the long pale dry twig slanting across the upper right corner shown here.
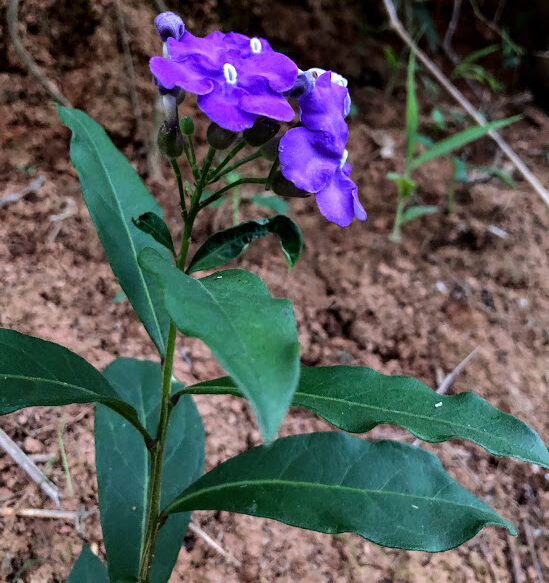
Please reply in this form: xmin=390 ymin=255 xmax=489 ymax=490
xmin=383 ymin=0 xmax=549 ymax=205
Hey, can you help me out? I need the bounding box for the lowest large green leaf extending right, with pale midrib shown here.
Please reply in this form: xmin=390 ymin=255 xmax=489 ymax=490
xmin=165 ymin=432 xmax=516 ymax=552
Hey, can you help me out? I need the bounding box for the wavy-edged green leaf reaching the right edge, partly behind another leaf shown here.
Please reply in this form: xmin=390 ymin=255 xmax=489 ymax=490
xmin=184 ymin=366 xmax=549 ymax=467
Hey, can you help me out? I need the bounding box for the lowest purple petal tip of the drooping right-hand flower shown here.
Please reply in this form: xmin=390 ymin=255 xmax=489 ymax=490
xmin=315 ymin=171 xmax=360 ymax=227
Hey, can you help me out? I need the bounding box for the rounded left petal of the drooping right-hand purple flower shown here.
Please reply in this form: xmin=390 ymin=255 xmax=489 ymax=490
xmin=278 ymin=127 xmax=340 ymax=193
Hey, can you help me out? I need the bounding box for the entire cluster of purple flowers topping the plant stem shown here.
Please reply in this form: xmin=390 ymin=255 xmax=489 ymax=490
xmin=150 ymin=12 xmax=366 ymax=226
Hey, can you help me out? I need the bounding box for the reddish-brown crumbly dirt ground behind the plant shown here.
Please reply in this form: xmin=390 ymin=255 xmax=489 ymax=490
xmin=0 ymin=0 xmax=549 ymax=583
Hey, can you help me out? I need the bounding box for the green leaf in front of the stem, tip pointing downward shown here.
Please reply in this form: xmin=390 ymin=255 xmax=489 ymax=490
xmin=139 ymin=249 xmax=299 ymax=441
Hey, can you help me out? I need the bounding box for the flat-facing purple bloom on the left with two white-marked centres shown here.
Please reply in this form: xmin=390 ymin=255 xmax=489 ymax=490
xmin=150 ymin=31 xmax=297 ymax=132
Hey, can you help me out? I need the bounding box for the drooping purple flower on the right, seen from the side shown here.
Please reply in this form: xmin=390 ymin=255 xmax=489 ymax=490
xmin=278 ymin=72 xmax=366 ymax=227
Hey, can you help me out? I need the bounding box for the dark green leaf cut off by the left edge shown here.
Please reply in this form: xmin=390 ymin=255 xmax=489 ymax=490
xmin=0 ymin=328 xmax=146 ymax=438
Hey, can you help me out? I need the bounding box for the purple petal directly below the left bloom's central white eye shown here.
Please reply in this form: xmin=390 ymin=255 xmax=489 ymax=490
xmin=197 ymin=83 xmax=257 ymax=132
